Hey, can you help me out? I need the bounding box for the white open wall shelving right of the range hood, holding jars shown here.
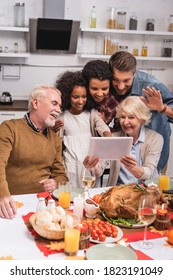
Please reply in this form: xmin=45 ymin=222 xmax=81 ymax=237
xmin=80 ymin=28 xmax=173 ymax=62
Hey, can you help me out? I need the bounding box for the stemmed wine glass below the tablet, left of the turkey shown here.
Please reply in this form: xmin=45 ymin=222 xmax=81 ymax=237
xmin=81 ymin=166 xmax=96 ymax=199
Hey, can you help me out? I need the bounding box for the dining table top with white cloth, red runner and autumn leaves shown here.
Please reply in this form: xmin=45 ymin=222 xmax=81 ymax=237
xmin=0 ymin=188 xmax=173 ymax=260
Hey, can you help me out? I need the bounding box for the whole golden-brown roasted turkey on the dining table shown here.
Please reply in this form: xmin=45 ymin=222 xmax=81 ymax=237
xmin=100 ymin=184 xmax=161 ymax=219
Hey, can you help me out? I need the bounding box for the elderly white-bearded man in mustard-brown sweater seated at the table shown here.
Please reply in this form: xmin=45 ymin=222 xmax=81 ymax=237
xmin=0 ymin=85 xmax=68 ymax=219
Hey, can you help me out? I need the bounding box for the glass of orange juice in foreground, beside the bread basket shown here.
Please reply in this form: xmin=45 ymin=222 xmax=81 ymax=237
xmin=64 ymin=228 xmax=80 ymax=256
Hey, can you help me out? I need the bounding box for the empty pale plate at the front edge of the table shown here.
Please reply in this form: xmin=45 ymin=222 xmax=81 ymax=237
xmin=86 ymin=243 xmax=137 ymax=260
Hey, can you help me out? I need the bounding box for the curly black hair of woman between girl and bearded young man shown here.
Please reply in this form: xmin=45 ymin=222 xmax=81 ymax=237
xmin=82 ymin=60 xmax=112 ymax=87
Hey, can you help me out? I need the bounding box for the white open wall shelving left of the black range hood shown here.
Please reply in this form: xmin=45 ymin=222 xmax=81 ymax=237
xmin=0 ymin=26 xmax=29 ymax=59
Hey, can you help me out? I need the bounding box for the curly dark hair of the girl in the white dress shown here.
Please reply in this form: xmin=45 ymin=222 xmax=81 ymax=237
xmin=55 ymin=71 xmax=91 ymax=111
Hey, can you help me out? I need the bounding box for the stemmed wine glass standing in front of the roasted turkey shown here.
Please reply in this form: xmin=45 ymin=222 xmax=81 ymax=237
xmin=138 ymin=192 xmax=157 ymax=249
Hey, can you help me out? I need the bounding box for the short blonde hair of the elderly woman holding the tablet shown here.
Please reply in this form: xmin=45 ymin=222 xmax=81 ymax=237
xmin=116 ymin=96 xmax=152 ymax=125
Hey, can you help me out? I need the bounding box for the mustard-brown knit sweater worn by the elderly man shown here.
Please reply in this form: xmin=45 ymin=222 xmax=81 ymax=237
xmin=0 ymin=118 xmax=67 ymax=197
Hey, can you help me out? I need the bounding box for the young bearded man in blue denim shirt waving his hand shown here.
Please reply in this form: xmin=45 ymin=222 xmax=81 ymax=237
xmin=109 ymin=51 xmax=173 ymax=171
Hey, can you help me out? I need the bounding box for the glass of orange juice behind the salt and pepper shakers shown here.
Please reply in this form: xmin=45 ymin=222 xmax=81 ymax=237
xmin=58 ymin=182 xmax=71 ymax=209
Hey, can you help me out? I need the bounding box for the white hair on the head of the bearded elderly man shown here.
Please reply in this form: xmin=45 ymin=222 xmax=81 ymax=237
xmin=28 ymin=84 xmax=61 ymax=112
